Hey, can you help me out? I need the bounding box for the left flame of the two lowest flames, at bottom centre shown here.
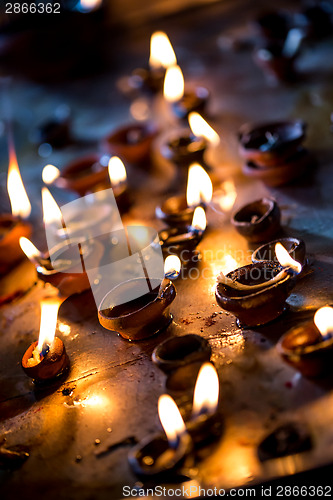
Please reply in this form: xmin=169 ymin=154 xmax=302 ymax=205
xmin=158 ymin=394 xmax=186 ymax=448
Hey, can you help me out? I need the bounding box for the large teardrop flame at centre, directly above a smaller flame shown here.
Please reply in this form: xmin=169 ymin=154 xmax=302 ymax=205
xmin=186 ymin=163 xmax=213 ymax=207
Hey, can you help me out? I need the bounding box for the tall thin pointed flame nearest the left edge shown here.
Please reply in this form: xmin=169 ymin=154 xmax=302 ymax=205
xmin=7 ymin=147 xmax=31 ymax=219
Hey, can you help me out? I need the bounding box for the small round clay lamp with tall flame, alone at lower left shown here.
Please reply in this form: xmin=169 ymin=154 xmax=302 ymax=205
xmin=22 ymin=297 xmax=69 ymax=385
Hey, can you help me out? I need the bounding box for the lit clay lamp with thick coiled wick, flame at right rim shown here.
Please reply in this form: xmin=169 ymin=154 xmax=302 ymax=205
xmin=215 ymin=243 xmax=302 ymax=327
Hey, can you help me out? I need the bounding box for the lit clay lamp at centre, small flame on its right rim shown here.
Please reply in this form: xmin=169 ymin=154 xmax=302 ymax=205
xmin=98 ymin=255 xmax=180 ymax=341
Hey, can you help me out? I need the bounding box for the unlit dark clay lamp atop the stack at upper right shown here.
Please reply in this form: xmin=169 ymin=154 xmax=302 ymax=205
xmin=238 ymin=120 xmax=306 ymax=168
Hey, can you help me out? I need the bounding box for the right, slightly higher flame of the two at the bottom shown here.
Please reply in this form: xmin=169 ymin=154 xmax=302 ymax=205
xmin=193 ymin=363 xmax=219 ymax=416
